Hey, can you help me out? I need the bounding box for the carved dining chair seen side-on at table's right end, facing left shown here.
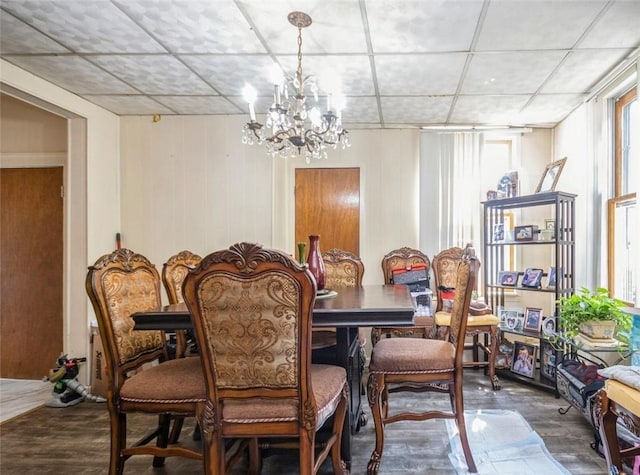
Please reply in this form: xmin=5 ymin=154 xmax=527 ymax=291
xmin=367 ymin=248 xmax=478 ymax=475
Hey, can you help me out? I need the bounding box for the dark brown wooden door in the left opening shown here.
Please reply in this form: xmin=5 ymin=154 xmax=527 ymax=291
xmin=0 ymin=167 xmax=63 ymax=379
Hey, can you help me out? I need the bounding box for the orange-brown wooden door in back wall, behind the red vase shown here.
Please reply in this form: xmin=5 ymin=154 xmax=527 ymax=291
xmin=295 ymin=168 xmax=360 ymax=255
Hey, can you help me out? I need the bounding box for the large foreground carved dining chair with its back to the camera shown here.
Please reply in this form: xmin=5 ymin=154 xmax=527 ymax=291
xmin=183 ymin=242 xmax=348 ymax=475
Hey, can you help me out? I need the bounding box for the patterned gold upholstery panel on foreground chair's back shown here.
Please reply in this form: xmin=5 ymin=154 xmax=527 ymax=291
xmin=198 ymin=274 xmax=300 ymax=388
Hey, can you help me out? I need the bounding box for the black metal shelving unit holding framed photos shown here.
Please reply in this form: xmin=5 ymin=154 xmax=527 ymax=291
xmin=482 ymin=191 xmax=576 ymax=394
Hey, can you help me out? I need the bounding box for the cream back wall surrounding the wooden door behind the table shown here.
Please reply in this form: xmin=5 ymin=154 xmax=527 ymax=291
xmin=121 ymin=116 xmax=419 ymax=283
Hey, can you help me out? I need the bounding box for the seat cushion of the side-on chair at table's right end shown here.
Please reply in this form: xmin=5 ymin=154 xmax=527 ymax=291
xmin=369 ymin=338 xmax=455 ymax=374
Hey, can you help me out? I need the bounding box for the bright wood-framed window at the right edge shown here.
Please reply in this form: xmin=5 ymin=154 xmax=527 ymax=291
xmin=608 ymin=87 xmax=640 ymax=306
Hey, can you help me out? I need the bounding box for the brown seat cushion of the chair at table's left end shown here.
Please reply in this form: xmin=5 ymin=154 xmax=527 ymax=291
xmin=120 ymin=358 xmax=206 ymax=405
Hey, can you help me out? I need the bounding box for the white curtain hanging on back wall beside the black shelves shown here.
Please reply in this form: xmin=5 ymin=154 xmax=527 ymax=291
xmin=420 ymin=132 xmax=486 ymax=257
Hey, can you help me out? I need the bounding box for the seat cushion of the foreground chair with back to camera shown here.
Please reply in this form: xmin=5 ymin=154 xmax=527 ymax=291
xmin=222 ymin=364 xmax=347 ymax=428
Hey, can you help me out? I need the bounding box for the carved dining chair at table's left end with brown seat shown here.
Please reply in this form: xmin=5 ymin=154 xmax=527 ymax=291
xmin=86 ymin=249 xmax=205 ymax=475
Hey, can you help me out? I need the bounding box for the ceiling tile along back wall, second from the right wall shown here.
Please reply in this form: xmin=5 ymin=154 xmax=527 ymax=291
xmin=450 ymin=95 xmax=531 ymax=125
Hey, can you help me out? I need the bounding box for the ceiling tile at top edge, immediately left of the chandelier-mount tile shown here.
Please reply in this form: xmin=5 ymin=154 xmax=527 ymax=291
xmin=116 ymin=0 xmax=265 ymax=53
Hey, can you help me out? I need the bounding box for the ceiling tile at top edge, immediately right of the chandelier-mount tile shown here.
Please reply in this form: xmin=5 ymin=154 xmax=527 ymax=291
xmin=366 ymin=0 xmax=482 ymax=53
